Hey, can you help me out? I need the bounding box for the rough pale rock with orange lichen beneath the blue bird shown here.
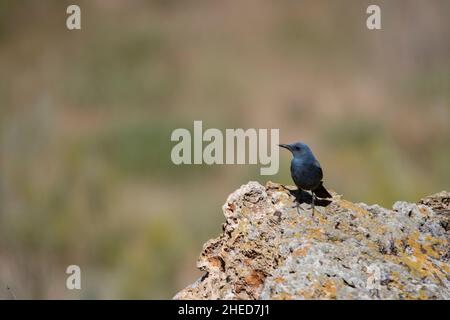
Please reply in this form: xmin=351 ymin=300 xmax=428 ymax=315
xmin=174 ymin=182 xmax=450 ymax=299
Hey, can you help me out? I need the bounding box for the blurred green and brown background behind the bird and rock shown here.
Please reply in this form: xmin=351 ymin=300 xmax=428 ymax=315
xmin=0 ymin=0 xmax=450 ymax=299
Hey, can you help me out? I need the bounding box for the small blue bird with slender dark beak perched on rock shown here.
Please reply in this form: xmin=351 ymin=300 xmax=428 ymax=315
xmin=279 ymin=142 xmax=332 ymax=212
